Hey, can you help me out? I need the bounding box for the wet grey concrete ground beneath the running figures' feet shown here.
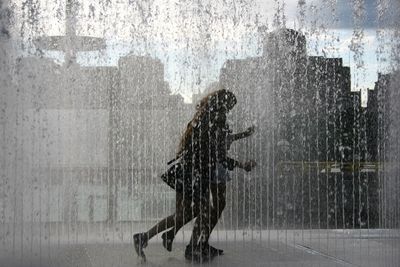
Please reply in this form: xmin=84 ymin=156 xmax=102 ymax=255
xmin=0 ymin=230 xmax=400 ymax=267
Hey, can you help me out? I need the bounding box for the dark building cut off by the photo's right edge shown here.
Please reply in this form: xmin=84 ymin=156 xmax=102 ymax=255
xmin=363 ymin=70 xmax=400 ymax=227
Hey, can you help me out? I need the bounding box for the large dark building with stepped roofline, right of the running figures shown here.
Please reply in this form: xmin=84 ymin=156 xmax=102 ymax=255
xmin=219 ymin=28 xmax=386 ymax=228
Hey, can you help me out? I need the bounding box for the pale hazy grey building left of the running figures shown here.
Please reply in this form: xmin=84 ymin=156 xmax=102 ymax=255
xmin=6 ymin=47 xmax=192 ymax=223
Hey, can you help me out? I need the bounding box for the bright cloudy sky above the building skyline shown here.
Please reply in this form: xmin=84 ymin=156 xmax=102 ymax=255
xmin=13 ymin=0 xmax=400 ymax=101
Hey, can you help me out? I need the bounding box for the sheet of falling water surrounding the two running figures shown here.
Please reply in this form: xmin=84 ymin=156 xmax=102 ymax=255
xmin=0 ymin=0 xmax=400 ymax=266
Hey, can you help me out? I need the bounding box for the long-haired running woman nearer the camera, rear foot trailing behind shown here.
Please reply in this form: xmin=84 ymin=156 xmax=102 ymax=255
xmin=133 ymin=89 xmax=255 ymax=260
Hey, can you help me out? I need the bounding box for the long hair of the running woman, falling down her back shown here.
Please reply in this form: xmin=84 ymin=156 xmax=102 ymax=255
xmin=176 ymin=89 xmax=237 ymax=157
